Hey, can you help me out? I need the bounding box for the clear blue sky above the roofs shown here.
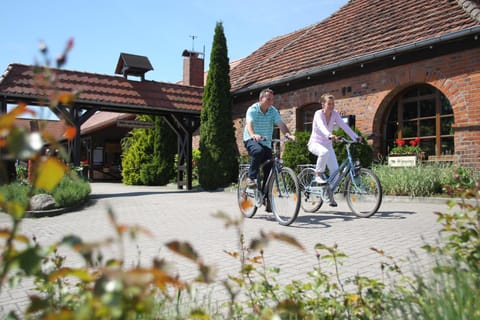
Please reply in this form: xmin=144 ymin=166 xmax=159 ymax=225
xmin=0 ymin=0 xmax=348 ymax=82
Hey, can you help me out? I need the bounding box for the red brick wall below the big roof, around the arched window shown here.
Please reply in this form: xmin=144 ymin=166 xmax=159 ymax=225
xmin=233 ymin=49 xmax=480 ymax=169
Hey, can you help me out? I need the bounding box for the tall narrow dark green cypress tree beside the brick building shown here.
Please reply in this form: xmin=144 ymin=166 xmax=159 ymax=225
xmin=198 ymin=22 xmax=238 ymax=190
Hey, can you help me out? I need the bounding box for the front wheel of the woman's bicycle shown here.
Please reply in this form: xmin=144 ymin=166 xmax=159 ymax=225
xmin=344 ymin=168 xmax=382 ymax=218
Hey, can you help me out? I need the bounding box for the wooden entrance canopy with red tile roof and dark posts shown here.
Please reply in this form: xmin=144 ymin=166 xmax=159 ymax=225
xmin=0 ymin=64 xmax=203 ymax=190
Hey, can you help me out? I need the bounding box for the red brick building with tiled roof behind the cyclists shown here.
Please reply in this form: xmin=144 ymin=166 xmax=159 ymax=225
xmin=231 ymin=0 xmax=480 ymax=168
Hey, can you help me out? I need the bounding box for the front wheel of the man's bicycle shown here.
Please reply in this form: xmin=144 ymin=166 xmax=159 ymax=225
xmin=268 ymin=167 xmax=300 ymax=226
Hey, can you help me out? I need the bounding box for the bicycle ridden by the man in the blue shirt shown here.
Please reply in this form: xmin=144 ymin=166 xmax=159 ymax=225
xmin=237 ymin=139 xmax=300 ymax=226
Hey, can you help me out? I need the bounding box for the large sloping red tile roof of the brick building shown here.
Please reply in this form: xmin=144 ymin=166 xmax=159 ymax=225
xmin=230 ymin=0 xmax=480 ymax=91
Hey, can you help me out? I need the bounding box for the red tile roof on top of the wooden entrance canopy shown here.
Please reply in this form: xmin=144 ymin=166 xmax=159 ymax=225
xmin=0 ymin=64 xmax=203 ymax=114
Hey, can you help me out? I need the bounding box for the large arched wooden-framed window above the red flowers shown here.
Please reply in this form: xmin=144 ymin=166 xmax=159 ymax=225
xmin=386 ymin=84 xmax=455 ymax=156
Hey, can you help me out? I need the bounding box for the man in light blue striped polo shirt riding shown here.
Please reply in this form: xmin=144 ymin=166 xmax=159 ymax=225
xmin=243 ymin=89 xmax=295 ymax=188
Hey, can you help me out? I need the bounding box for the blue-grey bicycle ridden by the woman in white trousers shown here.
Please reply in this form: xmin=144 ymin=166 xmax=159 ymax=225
xmin=298 ymin=138 xmax=382 ymax=218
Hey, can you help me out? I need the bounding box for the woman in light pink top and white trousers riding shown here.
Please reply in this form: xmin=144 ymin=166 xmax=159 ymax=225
xmin=308 ymin=94 xmax=362 ymax=207
